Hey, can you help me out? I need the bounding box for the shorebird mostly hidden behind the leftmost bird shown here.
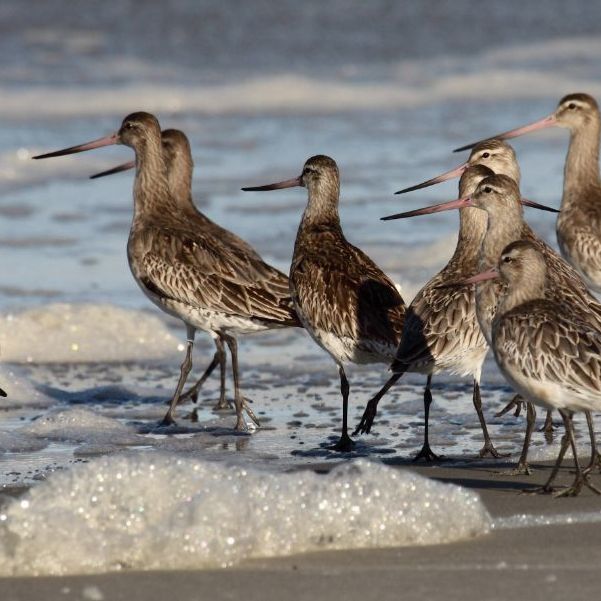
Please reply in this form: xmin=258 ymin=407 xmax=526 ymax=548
xmin=90 ymin=129 xmax=264 ymax=410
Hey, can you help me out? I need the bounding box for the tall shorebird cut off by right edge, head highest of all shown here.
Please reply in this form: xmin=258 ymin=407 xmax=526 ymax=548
xmin=456 ymin=94 xmax=601 ymax=292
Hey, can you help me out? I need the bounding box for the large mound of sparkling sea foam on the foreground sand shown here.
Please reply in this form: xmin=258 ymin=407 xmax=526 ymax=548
xmin=0 ymin=453 xmax=491 ymax=575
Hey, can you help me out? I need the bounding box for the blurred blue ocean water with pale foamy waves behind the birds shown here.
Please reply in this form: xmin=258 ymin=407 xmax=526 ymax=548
xmin=0 ymin=0 xmax=601 ymax=482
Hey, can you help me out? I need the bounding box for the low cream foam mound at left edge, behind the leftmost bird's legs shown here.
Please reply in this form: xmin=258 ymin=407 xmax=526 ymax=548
xmin=0 ymin=303 xmax=180 ymax=363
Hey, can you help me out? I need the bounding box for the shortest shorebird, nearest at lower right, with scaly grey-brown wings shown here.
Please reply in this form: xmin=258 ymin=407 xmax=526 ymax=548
xmin=470 ymin=240 xmax=601 ymax=496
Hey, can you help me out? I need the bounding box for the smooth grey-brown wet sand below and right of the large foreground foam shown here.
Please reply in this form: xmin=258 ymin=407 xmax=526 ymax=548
xmin=0 ymin=462 xmax=601 ymax=601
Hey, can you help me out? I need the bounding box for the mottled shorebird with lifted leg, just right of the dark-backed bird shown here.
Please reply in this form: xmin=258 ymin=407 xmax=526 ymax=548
xmin=355 ymin=165 xmax=494 ymax=461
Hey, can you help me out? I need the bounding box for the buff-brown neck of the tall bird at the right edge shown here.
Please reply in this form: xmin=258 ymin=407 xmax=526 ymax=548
xmin=563 ymin=115 xmax=601 ymax=203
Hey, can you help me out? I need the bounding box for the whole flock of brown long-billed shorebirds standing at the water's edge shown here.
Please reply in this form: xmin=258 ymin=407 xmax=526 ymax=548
xmin=29 ymin=94 xmax=601 ymax=496
